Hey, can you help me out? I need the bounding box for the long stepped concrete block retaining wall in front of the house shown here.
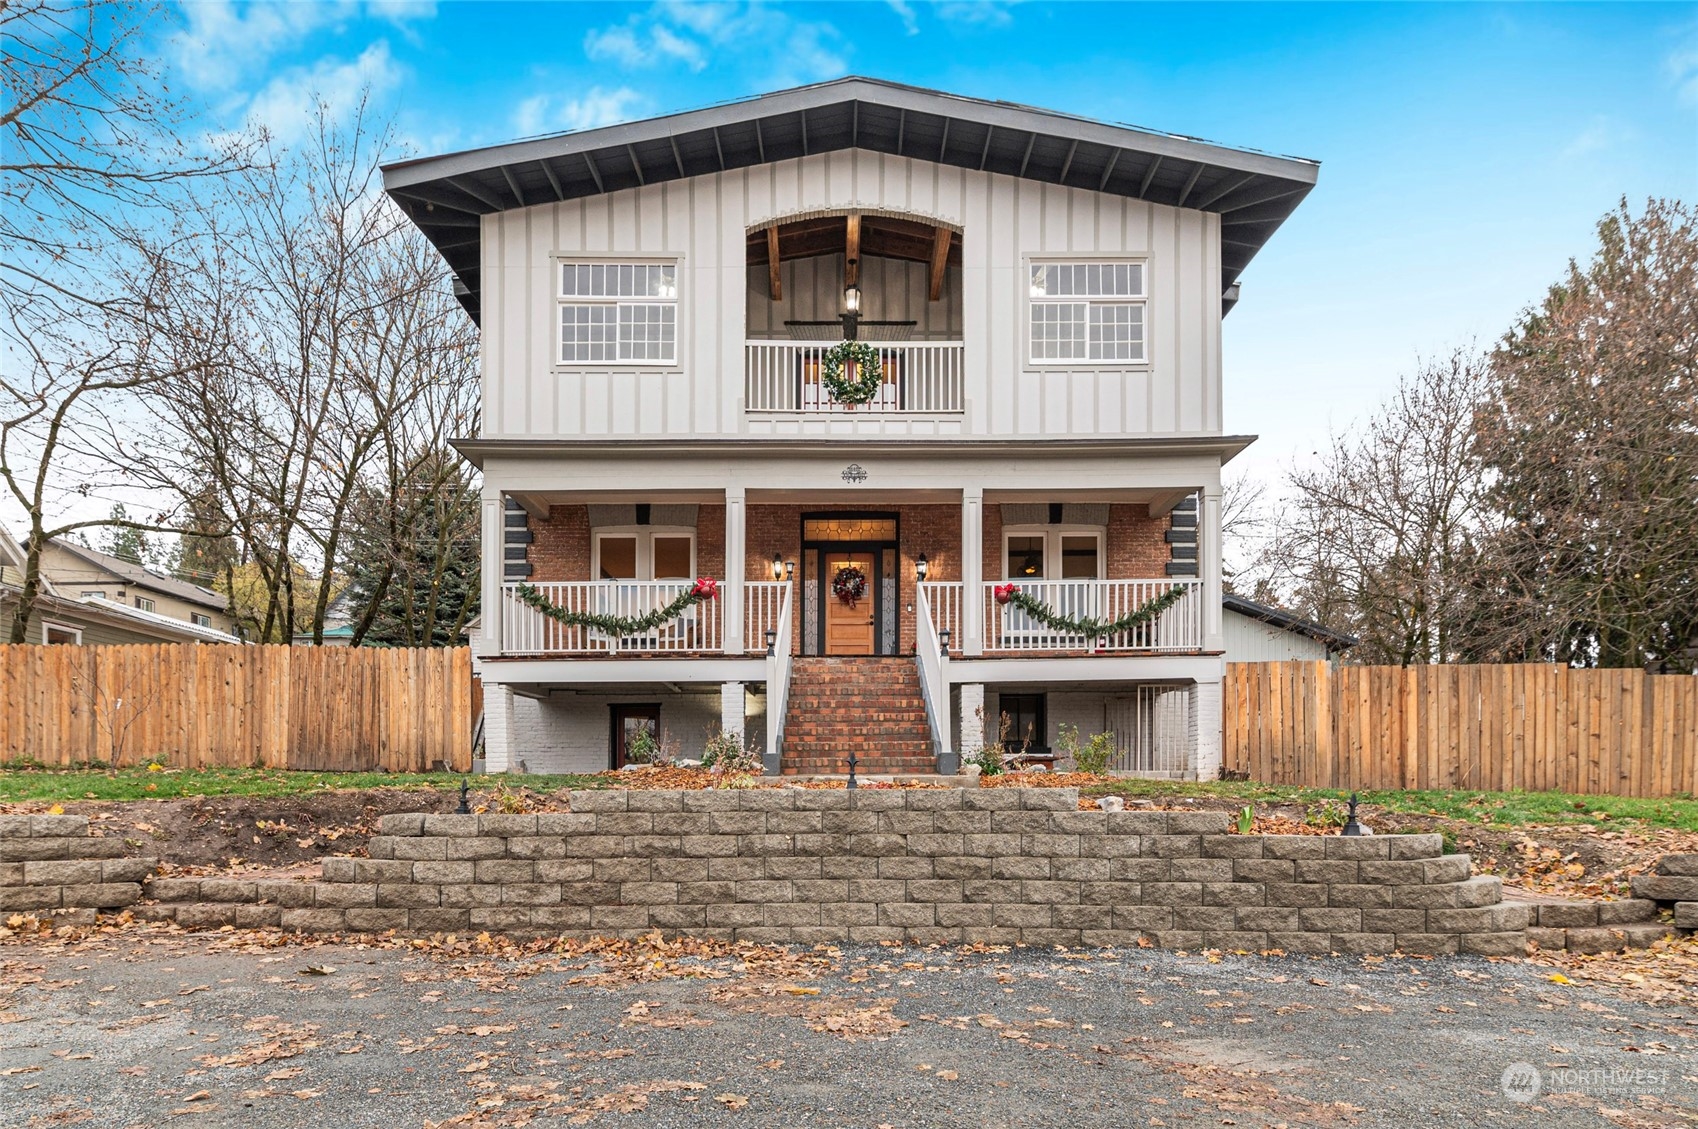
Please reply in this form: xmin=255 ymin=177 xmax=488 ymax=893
xmin=144 ymin=788 xmax=1528 ymax=954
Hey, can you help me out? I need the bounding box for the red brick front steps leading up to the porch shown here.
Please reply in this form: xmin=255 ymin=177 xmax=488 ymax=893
xmin=781 ymin=657 xmax=937 ymax=776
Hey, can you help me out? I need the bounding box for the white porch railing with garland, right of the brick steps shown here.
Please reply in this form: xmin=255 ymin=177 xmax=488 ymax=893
xmin=983 ymin=579 xmax=1202 ymax=652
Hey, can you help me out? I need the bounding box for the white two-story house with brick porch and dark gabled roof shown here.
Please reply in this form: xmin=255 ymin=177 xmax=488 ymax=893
xmin=384 ymin=78 xmax=1318 ymax=778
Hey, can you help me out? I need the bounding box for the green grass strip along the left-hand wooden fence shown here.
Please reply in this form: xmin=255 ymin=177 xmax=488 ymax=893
xmin=0 ymin=767 xmax=606 ymax=803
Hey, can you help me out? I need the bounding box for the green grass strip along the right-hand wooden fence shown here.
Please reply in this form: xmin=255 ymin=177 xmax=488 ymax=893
xmin=1085 ymin=779 xmax=1698 ymax=830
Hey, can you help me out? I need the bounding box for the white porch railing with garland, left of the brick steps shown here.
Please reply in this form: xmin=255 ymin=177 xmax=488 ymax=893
xmin=501 ymin=581 xmax=722 ymax=655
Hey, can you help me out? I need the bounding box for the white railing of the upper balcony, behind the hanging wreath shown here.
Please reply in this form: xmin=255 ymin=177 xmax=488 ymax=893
xmin=744 ymin=341 xmax=964 ymax=414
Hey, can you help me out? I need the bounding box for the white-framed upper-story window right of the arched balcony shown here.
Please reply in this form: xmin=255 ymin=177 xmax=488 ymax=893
xmin=1031 ymin=263 xmax=1144 ymax=363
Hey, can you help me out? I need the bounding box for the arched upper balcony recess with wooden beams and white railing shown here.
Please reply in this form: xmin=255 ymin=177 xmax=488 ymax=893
xmin=744 ymin=212 xmax=966 ymax=419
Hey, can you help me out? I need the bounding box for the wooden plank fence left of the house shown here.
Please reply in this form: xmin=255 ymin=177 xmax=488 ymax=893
xmin=0 ymin=643 xmax=475 ymax=772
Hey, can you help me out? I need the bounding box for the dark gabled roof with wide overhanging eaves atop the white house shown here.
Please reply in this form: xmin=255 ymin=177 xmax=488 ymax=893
xmin=384 ymin=78 xmax=1319 ymax=319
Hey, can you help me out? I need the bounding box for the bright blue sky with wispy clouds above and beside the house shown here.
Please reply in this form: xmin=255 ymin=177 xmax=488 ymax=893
xmin=158 ymin=0 xmax=1698 ymax=477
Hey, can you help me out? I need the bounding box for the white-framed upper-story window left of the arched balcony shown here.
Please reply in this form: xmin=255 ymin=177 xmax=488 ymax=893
xmin=560 ymin=263 xmax=678 ymax=365
